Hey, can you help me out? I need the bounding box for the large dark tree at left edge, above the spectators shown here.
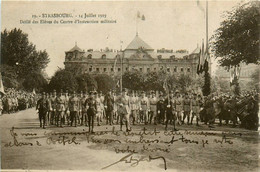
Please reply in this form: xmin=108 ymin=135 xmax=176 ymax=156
xmin=1 ymin=28 xmax=49 ymax=87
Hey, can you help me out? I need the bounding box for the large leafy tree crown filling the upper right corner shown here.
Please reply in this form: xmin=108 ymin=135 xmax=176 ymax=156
xmin=212 ymin=2 xmax=260 ymax=68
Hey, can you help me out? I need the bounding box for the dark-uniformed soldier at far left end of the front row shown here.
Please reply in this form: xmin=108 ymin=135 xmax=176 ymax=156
xmin=36 ymin=92 xmax=49 ymax=129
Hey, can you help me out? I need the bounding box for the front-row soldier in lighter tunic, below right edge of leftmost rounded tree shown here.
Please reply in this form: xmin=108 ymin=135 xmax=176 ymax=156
xmin=69 ymin=91 xmax=80 ymax=127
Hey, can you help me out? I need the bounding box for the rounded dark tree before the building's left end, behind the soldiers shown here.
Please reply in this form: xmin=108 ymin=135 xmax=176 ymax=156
xmin=47 ymin=69 xmax=78 ymax=92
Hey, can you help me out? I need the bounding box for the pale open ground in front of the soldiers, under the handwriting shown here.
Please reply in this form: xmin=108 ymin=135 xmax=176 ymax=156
xmin=0 ymin=109 xmax=260 ymax=171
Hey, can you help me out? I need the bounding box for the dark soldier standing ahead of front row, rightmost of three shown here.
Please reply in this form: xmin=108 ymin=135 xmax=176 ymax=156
xmin=164 ymin=91 xmax=177 ymax=131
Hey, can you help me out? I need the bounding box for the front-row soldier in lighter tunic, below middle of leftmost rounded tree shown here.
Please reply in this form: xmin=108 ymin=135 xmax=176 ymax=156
xmin=55 ymin=92 xmax=65 ymax=127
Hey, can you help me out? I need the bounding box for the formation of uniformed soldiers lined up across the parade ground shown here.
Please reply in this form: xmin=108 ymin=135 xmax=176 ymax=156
xmin=36 ymin=89 xmax=203 ymax=132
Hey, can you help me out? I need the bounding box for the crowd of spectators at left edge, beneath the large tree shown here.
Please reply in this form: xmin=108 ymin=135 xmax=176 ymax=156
xmin=0 ymin=88 xmax=38 ymax=115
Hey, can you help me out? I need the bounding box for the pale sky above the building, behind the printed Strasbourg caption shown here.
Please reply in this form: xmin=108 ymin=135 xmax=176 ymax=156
xmin=1 ymin=0 xmax=241 ymax=77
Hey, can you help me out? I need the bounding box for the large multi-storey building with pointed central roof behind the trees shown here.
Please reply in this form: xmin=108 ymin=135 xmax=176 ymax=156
xmin=64 ymin=35 xmax=200 ymax=77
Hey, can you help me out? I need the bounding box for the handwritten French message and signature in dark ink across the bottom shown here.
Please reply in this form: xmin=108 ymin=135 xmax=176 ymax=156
xmin=4 ymin=127 xmax=246 ymax=170
